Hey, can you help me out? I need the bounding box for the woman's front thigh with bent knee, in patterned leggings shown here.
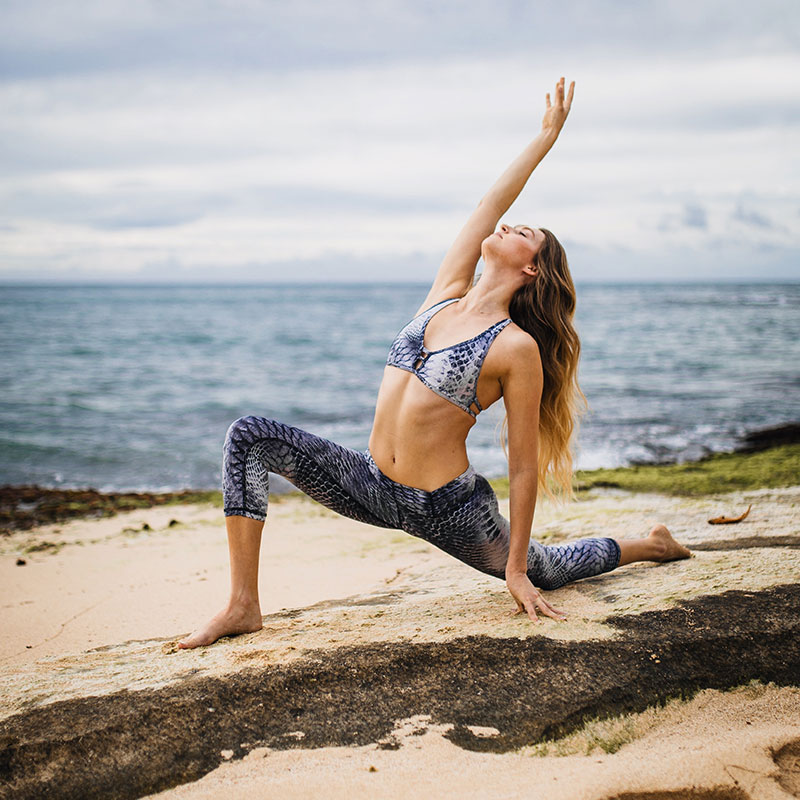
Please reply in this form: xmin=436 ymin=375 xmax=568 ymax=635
xmin=224 ymin=416 xmax=396 ymax=528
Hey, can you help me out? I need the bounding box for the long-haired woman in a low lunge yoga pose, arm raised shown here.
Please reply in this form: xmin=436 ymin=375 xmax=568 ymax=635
xmin=180 ymin=78 xmax=690 ymax=648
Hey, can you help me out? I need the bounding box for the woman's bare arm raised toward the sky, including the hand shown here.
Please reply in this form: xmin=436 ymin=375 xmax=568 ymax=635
xmin=420 ymin=78 xmax=575 ymax=312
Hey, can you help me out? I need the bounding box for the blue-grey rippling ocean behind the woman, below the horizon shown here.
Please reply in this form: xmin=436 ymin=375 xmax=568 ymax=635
xmin=0 ymin=284 xmax=800 ymax=491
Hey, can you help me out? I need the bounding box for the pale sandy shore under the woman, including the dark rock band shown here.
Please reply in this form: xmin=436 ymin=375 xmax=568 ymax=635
xmin=0 ymin=487 xmax=800 ymax=800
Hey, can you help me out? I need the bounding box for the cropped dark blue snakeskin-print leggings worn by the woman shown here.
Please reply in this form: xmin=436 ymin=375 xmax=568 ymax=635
xmin=222 ymin=416 xmax=620 ymax=589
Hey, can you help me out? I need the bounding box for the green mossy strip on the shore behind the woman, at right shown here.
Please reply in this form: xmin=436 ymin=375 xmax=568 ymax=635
xmin=491 ymin=444 xmax=800 ymax=497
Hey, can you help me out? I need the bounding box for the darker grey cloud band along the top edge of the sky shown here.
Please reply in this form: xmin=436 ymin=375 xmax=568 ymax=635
xmin=0 ymin=0 xmax=800 ymax=78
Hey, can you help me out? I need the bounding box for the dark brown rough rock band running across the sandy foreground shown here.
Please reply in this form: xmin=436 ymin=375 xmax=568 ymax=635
xmin=0 ymin=584 xmax=800 ymax=798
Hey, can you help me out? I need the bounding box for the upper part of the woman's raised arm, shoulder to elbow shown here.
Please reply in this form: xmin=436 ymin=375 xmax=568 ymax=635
xmin=417 ymin=200 xmax=500 ymax=314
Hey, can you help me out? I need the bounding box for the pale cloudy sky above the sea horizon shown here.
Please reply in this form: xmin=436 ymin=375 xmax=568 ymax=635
xmin=0 ymin=0 xmax=800 ymax=283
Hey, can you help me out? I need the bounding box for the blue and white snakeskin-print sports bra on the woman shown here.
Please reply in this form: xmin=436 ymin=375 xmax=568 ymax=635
xmin=386 ymin=297 xmax=511 ymax=418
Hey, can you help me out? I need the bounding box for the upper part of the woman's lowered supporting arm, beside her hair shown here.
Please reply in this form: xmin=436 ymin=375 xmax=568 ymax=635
xmin=502 ymin=333 xmax=544 ymax=475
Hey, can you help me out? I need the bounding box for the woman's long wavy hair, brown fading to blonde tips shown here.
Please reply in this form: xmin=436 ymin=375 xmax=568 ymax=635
xmin=500 ymin=228 xmax=587 ymax=500
